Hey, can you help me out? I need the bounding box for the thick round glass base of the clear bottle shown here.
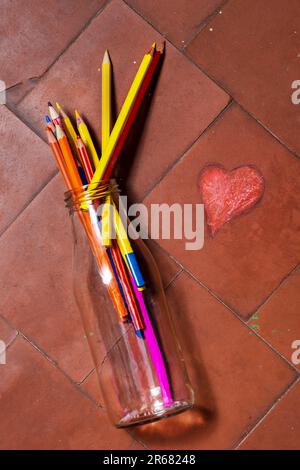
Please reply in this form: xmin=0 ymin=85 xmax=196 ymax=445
xmin=115 ymin=401 xmax=193 ymax=428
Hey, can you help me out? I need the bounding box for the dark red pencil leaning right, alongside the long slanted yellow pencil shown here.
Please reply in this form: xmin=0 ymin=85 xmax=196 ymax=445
xmin=103 ymin=46 xmax=163 ymax=180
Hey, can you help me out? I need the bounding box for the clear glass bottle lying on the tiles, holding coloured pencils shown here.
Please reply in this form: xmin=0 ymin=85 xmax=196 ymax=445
xmin=65 ymin=183 xmax=194 ymax=427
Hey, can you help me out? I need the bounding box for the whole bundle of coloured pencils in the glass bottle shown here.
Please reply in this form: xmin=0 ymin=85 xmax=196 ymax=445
xmin=46 ymin=44 xmax=172 ymax=406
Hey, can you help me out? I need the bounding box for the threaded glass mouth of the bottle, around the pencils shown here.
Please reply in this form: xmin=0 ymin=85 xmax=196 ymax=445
xmin=64 ymin=180 xmax=119 ymax=212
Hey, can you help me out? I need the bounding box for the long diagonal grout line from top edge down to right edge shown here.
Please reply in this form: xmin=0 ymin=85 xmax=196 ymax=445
xmin=123 ymin=0 xmax=300 ymax=160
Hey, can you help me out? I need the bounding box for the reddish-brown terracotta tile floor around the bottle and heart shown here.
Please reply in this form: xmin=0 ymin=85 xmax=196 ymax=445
xmin=0 ymin=0 xmax=300 ymax=450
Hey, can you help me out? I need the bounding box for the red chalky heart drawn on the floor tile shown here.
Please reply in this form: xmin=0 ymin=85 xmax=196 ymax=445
xmin=198 ymin=165 xmax=265 ymax=236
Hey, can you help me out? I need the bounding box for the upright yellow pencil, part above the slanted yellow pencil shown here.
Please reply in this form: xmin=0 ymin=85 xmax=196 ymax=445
xmin=101 ymin=50 xmax=111 ymax=153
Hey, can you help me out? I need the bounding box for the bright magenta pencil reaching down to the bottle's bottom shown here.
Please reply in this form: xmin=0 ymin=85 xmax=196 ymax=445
xmin=130 ymin=276 xmax=173 ymax=406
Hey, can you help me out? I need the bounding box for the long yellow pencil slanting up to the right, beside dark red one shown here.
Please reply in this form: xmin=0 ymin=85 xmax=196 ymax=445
xmin=89 ymin=47 xmax=154 ymax=190
